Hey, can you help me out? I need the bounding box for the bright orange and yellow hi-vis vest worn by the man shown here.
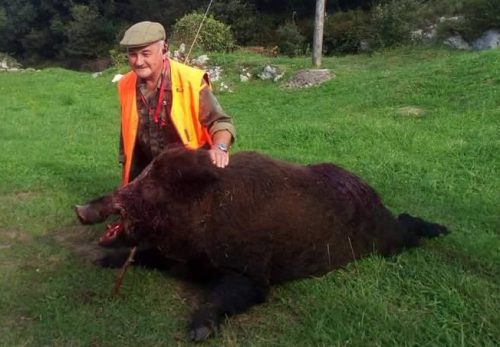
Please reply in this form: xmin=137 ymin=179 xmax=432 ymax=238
xmin=118 ymin=60 xmax=212 ymax=185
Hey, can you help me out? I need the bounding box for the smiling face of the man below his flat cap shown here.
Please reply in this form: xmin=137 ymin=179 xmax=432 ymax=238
xmin=127 ymin=41 xmax=164 ymax=81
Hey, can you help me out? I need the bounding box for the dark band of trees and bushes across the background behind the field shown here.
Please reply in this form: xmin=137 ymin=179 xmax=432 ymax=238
xmin=0 ymin=0 xmax=500 ymax=67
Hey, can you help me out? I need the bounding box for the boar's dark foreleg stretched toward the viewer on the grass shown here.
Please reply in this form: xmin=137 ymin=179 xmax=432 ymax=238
xmin=189 ymin=273 xmax=268 ymax=341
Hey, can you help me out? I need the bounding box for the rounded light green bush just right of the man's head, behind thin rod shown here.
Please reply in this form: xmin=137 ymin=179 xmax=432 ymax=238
xmin=171 ymin=12 xmax=235 ymax=52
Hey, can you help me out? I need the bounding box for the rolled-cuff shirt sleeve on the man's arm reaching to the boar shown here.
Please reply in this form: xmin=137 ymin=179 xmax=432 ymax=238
xmin=199 ymin=83 xmax=236 ymax=142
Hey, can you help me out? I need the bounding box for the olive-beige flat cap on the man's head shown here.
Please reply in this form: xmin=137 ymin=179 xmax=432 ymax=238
xmin=120 ymin=21 xmax=166 ymax=48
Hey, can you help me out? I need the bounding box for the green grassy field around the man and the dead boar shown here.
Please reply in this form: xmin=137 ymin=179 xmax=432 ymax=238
xmin=0 ymin=49 xmax=500 ymax=346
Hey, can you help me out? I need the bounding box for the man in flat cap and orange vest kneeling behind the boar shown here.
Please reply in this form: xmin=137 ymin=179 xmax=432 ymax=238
xmin=118 ymin=21 xmax=235 ymax=185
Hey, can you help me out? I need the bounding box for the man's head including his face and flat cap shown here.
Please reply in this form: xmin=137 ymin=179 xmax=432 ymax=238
xmin=120 ymin=22 xmax=167 ymax=82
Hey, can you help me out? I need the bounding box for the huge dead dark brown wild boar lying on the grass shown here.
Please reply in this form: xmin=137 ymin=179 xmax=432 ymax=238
xmin=77 ymin=149 xmax=446 ymax=340
